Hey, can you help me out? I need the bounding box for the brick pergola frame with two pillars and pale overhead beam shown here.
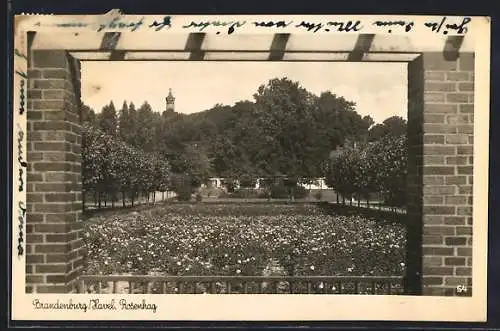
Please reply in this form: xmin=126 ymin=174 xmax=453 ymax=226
xmin=26 ymin=32 xmax=474 ymax=295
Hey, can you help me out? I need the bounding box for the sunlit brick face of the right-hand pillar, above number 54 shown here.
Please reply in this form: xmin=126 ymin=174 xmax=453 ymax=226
xmin=408 ymin=53 xmax=474 ymax=296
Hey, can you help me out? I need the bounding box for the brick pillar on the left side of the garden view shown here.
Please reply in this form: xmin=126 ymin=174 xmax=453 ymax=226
xmin=26 ymin=50 xmax=85 ymax=293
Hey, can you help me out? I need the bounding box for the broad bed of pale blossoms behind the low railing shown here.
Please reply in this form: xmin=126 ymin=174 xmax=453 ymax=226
xmin=85 ymin=204 xmax=405 ymax=276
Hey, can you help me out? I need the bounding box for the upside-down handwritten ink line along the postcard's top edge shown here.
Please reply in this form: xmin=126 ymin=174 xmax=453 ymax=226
xmin=47 ymin=16 xmax=471 ymax=35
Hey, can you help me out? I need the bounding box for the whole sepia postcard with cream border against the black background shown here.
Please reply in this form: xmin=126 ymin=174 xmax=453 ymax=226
xmin=12 ymin=12 xmax=489 ymax=319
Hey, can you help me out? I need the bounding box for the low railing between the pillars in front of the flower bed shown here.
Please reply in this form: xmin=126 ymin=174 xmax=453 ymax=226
xmin=77 ymin=275 xmax=403 ymax=295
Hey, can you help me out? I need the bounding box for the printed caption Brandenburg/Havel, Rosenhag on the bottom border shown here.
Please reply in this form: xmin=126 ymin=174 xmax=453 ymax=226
xmin=32 ymin=299 xmax=158 ymax=313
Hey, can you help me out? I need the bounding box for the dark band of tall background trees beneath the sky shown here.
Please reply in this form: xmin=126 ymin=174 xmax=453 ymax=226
xmin=82 ymin=78 xmax=406 ymax=205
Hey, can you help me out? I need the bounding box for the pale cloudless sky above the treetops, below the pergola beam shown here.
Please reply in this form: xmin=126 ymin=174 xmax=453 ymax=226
xmin=81 ymin=61 xmax=407 ymax=123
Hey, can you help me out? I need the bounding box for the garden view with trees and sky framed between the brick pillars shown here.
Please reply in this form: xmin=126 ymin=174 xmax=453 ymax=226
xmin=78 ymin=61 xmax=412 ymax=294
